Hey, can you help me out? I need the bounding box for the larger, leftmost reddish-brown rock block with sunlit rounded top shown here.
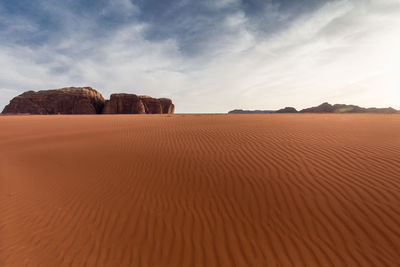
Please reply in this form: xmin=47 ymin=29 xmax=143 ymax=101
xmin=3 ymin=87 xmax=104 ymax=114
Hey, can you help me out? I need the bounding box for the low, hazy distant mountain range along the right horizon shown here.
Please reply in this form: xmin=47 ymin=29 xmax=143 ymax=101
xmin=228 ymin=102 xmax=400 ymax=114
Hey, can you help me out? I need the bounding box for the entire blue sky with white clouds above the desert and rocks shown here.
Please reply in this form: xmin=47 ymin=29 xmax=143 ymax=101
xmin=0 ymin=0 xmax=400 ymax=113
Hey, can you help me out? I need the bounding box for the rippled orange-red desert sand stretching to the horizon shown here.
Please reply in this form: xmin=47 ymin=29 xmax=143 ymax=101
xmin=0 ymin=114 xmax=400 ymax=267
